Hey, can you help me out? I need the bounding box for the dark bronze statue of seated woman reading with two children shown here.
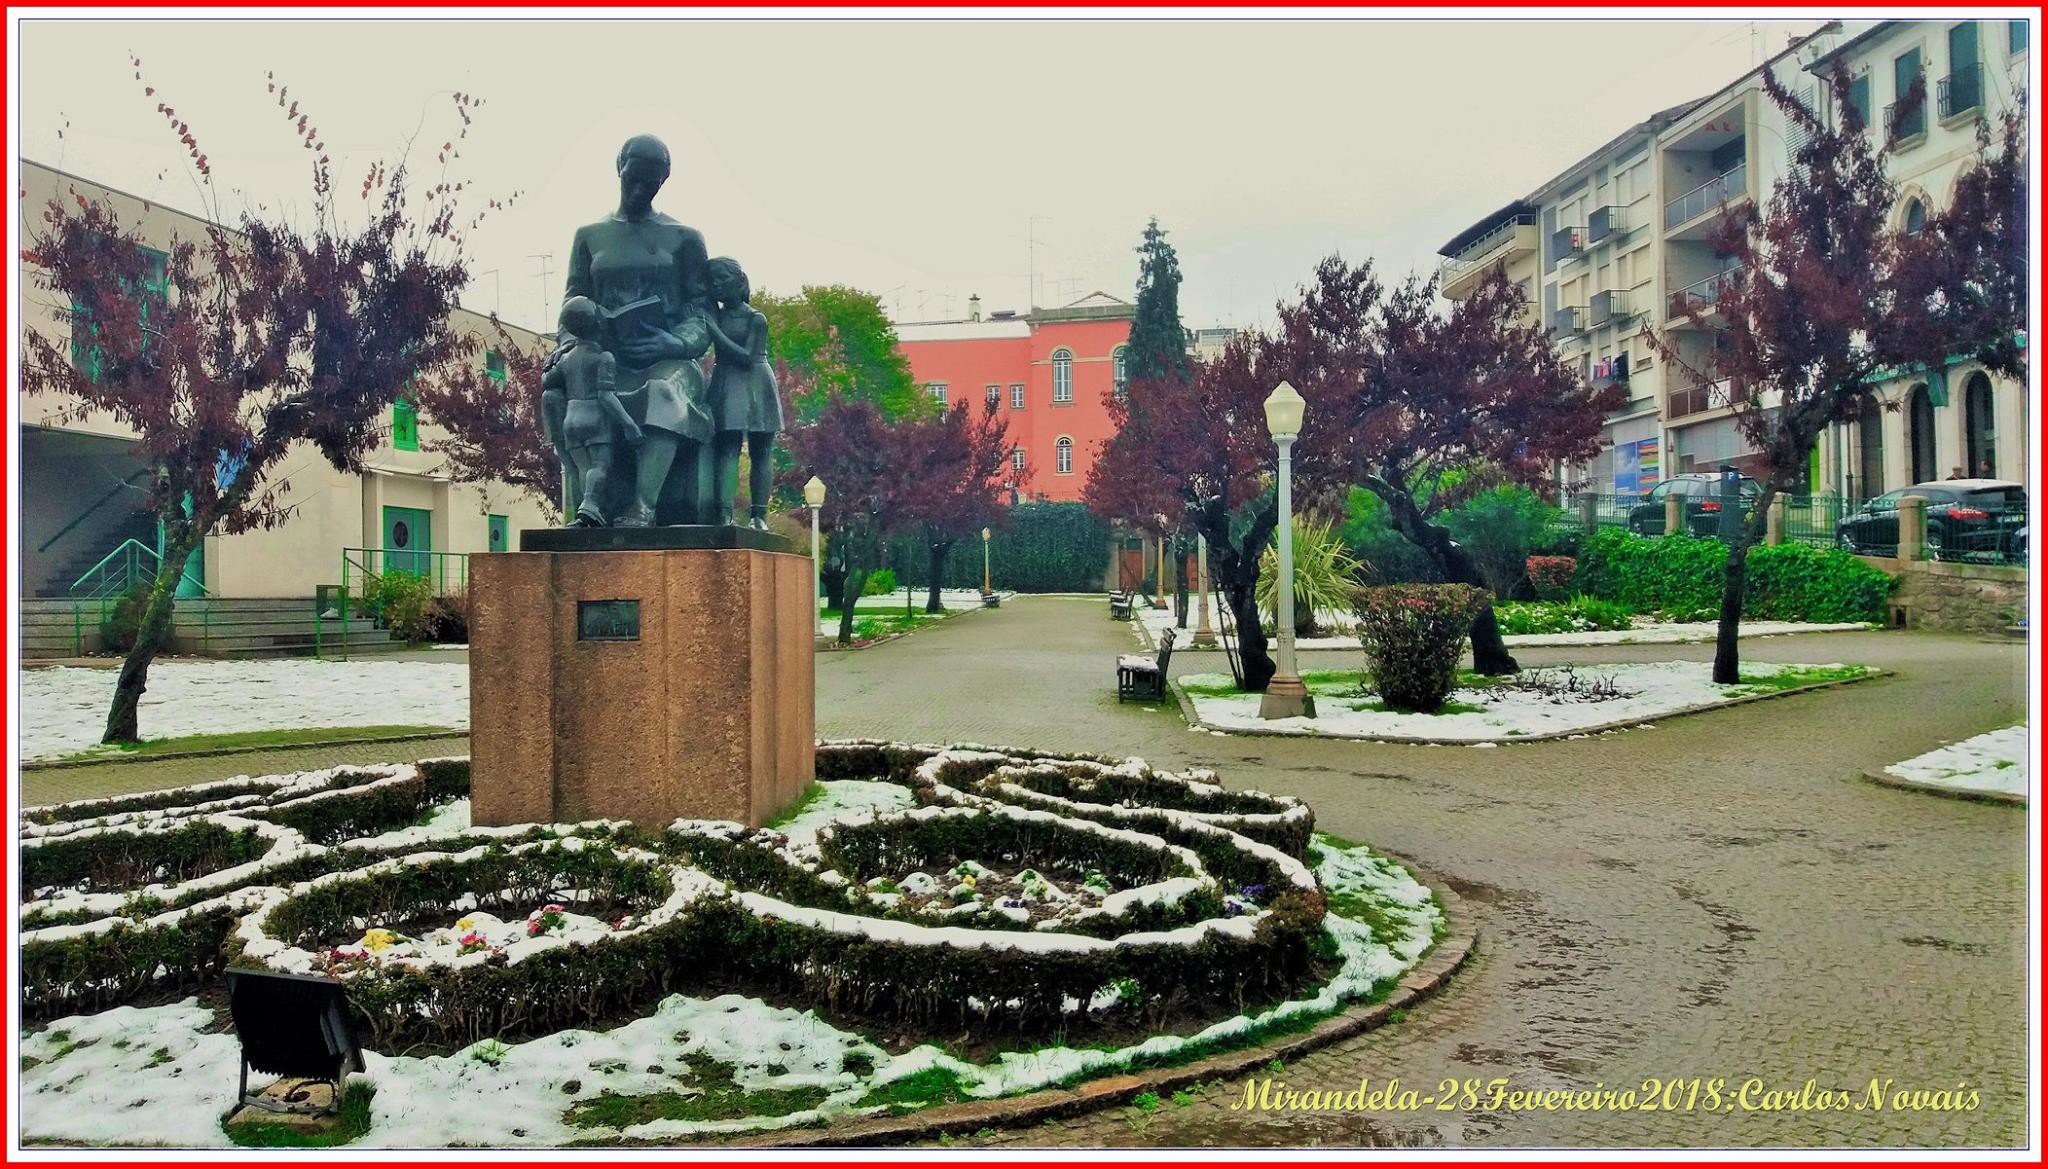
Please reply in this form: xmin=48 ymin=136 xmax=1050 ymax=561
xmin=541 ymin=135 xmax=782 ymax=530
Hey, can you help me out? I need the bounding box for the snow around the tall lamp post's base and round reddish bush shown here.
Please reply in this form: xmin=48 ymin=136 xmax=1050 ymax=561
xmin=1180 ymin=661 xmax=1867 ymax=743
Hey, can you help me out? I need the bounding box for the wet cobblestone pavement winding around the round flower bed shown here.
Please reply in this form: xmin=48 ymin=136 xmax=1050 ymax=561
xmin=27 ymin=598 xmax=2028 ymax=1146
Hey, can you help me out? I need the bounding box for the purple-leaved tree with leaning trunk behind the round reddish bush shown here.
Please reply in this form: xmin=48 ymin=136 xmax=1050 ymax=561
xmin=1262 ymin=258 xmax=1622 ymax=674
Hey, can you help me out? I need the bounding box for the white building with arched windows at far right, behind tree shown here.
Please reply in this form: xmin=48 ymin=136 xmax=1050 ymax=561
xmin=1806 ymin=20 xmax=2030 ymax=500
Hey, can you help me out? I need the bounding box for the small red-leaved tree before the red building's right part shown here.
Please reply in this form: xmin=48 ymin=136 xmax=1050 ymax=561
xmin=893 ymin=401 xmax=1010 ymax=612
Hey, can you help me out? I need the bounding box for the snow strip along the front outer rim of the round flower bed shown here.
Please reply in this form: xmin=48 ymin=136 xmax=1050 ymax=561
xmin=18 ymin=835 xmax=1442 ymax=1149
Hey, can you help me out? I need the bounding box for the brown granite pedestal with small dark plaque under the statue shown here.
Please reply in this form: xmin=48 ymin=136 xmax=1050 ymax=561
xmin=469 ymin=528 xmax=815 ymax=829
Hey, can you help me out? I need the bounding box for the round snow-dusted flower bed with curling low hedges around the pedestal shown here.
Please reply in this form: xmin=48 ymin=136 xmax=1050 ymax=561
xmin=20 ymin=743 xmax=1442 ymax=1146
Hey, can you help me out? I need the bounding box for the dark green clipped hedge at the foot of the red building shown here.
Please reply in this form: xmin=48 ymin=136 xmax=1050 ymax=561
xmin=889 ymin=504 xmax=1110 ymax=592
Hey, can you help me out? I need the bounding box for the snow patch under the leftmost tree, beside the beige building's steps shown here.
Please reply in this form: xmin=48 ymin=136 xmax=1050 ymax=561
xmin=20 ymin=657 xmax=469 ymax=760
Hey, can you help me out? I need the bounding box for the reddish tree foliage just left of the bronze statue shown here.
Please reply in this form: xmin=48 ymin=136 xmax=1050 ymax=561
xmin=410 ymin=319 xmax=573 ymax=516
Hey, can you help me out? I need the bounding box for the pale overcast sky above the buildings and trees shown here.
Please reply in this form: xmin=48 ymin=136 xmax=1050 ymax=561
xmin=16 ymin=18 xmax=1817 ymax=328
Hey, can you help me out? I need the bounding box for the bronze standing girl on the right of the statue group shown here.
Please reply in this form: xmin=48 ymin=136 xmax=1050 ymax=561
xmin=705 ymin=256 xmax=782 ymax=530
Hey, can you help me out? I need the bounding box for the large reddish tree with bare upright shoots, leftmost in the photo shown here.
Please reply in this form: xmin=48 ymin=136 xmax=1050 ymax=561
xmin=23 ymin=59 xmax=512 ymax=743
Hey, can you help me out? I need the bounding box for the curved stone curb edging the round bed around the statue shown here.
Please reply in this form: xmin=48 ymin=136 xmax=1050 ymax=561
xmin=719 ymin=850 xmax=1479 ymax=1149
